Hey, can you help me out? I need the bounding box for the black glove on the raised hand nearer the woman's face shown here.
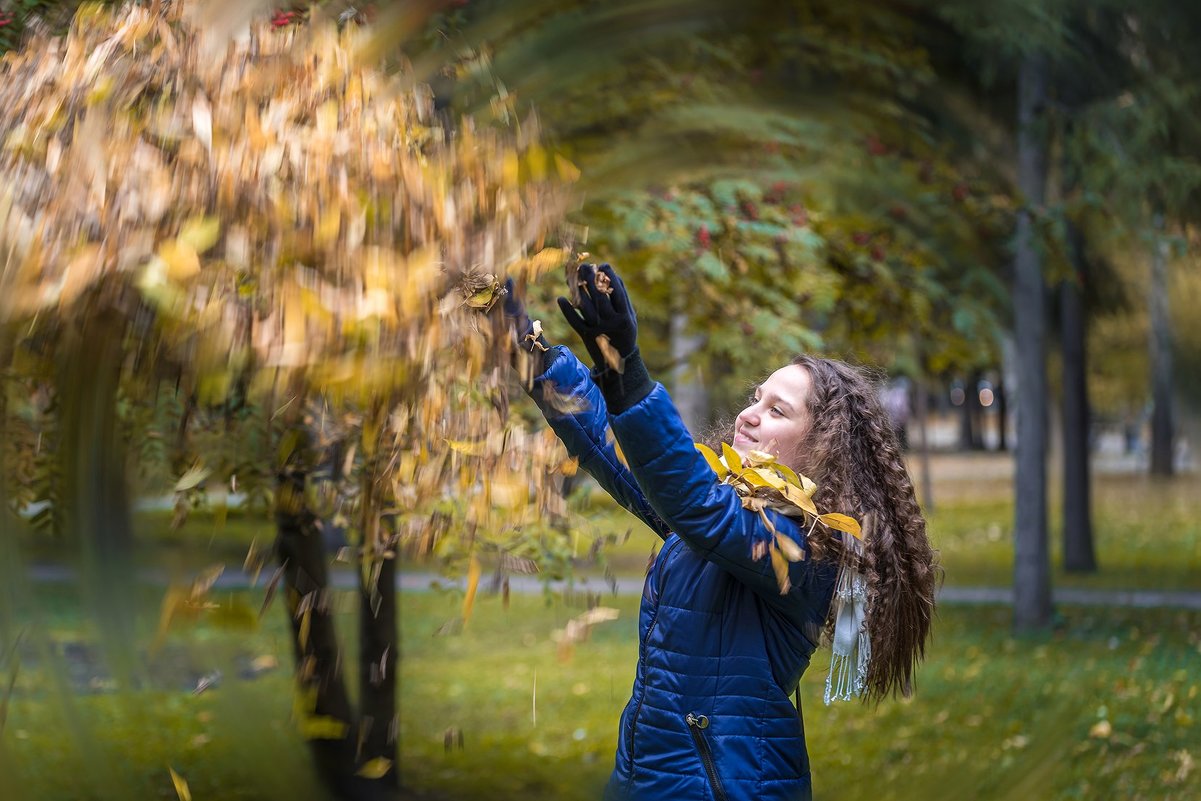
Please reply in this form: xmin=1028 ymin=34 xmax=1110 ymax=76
xmin=558 ymin=264 xmax=638 ymax=372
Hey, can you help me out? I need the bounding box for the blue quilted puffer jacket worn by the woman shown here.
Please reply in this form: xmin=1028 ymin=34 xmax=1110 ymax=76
xmin=532 ymin=347 xmax=835 ymax=801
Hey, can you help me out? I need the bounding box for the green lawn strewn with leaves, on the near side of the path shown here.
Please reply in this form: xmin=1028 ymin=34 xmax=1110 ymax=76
xmin=0 ymin=586 xmax=1201 ymax=801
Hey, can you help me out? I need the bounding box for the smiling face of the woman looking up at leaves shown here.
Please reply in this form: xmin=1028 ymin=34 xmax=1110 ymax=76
xmin=731 ymin=364 xmax=809 ymax=470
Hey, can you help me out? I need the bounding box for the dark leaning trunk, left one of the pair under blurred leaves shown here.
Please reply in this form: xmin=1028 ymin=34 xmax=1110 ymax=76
xmin=275 ymin=420 xmax=360 ymax=799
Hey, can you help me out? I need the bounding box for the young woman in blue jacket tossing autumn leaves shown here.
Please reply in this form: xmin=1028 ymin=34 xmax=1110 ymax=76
xmin=506 ymin=264 xmax=937 ymax=801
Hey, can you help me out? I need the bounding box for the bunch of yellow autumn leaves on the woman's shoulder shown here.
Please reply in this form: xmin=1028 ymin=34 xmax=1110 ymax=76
xmin=695 ymin=442 xmax=862 ymax=594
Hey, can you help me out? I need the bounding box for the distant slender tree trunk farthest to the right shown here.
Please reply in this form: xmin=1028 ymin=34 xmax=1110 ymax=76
xmin=1148 ymin=211 xmax=1175 ymax=476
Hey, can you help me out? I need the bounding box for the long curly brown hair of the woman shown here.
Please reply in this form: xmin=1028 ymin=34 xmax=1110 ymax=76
xmin=793 ymin=355 xmax=939 ymax=703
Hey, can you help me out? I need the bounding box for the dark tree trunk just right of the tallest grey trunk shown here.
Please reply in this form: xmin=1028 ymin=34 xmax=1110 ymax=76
xmin=1059 ymin=223 xmax=1097 ymax=573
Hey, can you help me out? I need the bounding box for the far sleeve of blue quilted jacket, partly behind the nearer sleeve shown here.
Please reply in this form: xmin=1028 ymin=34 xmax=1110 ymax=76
xmin=530 ymin=345 xmax=669 ymax=537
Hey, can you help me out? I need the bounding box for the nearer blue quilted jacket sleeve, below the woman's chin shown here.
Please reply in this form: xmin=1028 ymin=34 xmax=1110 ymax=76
xmin=611 ymin=384 xmax=832 ymax=624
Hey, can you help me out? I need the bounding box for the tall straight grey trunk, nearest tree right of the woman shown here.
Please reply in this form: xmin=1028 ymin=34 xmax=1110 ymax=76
xmin=1014 ymin=55 xmax=1051 ymax=630
